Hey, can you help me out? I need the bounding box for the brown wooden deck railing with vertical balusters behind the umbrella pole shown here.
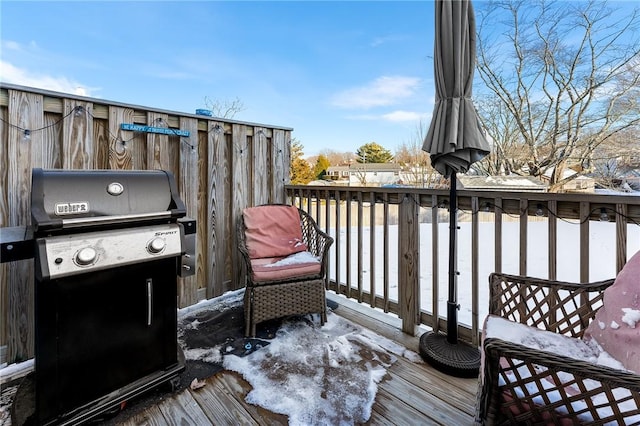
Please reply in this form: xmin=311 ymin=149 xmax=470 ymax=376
xmin=286 ymin=185 xmax=640 ymax=344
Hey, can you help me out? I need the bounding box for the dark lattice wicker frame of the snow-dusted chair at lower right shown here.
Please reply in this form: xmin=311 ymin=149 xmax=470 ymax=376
xmin=476 ymin=273 xmax=640 ymax=425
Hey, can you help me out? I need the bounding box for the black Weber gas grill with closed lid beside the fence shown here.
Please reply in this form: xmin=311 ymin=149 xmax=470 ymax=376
xmin=25 ymin=169 xmax=195 ymax=424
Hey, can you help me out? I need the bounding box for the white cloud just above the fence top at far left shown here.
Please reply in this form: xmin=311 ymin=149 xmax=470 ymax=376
xmin=0 ymin=60 xmax=99 ymax=96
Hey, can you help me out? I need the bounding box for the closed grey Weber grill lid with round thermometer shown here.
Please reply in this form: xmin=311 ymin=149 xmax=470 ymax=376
xmin=31 ymin=169 xmax=186 ymax=233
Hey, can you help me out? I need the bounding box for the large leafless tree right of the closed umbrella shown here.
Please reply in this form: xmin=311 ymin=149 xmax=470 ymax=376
xmin=475 ymin=0 xmax=640 ymax=190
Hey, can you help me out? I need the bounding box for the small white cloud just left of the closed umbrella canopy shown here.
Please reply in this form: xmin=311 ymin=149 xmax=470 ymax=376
xmin=332 ymin=76 xmax=420 ymax=109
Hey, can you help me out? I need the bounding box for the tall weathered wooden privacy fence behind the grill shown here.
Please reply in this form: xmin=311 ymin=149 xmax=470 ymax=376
xmin=0 ymin=83 xmax=292 ymax=363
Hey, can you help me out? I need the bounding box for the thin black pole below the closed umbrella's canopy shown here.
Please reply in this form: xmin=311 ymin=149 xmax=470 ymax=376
xmin=447 ymin=172 xmax=458 ymax=344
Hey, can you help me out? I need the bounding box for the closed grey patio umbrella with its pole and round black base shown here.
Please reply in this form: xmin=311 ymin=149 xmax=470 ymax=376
xmin=420 ymin=0 xmax=490 ymax=376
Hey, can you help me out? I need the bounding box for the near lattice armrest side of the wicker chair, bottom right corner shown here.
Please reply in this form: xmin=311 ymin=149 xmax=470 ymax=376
xmin=476 ymin=338 xmax=640 ymax=424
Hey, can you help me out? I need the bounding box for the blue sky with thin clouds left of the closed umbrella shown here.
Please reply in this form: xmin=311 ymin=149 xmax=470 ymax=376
xmin=0 ymin=0 xmax=434 ymax=156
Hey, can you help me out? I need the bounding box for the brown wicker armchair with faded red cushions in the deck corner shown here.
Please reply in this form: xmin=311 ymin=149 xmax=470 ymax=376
xmin=237 ymin=204 xmax=333 ymax=336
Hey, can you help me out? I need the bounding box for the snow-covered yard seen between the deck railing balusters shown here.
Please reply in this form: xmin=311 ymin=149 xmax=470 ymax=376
xmin=330 ymin=221 xmax=640 ymax=325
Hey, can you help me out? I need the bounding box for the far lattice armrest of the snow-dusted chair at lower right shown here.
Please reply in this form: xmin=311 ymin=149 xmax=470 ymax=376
xmin=489 ymin=273 xmax=614 ymax=337
